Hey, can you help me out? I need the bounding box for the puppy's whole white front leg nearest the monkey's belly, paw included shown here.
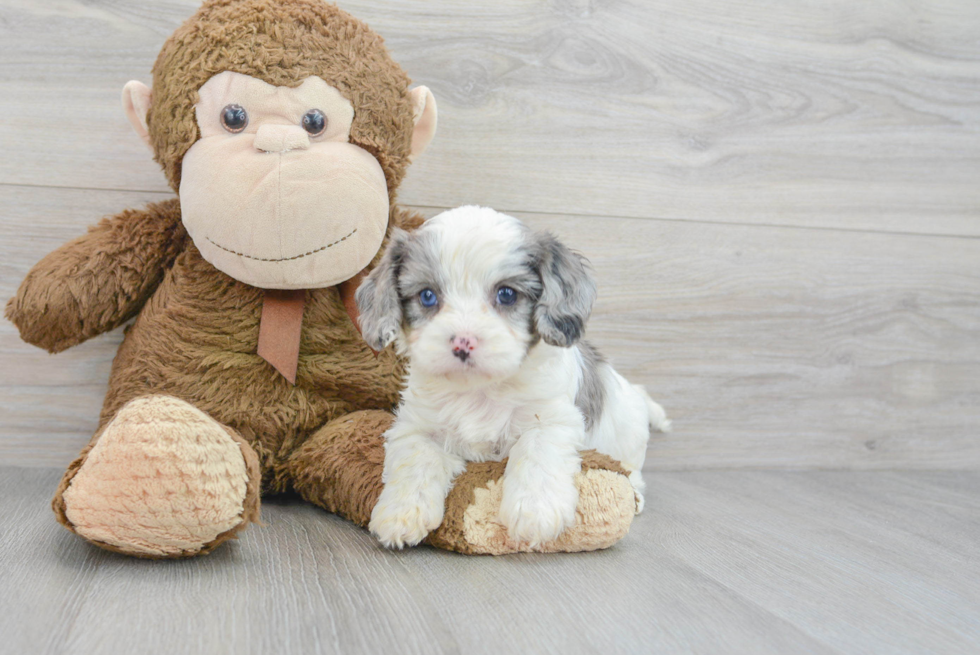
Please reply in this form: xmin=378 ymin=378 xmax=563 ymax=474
xmin=368 ymin=422 xmax=466 ymax=548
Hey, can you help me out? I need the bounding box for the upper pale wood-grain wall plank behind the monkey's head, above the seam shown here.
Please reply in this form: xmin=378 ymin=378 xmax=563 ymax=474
xmin=0 ymin=0 xmax=980 ymax=236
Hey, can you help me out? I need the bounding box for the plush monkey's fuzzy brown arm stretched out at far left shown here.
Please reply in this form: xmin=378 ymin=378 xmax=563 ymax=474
xmin=5 ymin=198 xmax=187 ymax=353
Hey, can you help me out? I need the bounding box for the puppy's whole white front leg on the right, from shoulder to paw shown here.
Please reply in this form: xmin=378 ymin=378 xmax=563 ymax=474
xmin=500 ymin=403 xmax=585 ymax=547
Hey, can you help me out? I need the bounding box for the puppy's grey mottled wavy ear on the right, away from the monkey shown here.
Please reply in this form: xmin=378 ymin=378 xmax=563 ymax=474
xmin=533 ymin=232 xmax=596 ymax=348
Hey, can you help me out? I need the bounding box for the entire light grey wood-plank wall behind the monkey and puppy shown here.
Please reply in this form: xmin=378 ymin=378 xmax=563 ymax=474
xmin=0 ymin=0 xmax=980 ymax=469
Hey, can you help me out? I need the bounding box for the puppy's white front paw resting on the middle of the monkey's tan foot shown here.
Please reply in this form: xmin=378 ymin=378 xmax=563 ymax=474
xmin=500 ymin=477 xmax=578 ymax=548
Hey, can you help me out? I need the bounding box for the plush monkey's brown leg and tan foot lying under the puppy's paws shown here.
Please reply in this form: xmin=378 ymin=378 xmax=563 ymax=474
xmin=284 ymin=410 xmax=636 ymax=555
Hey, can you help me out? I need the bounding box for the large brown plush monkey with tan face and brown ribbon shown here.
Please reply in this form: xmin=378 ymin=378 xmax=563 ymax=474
xmin=6 ymin=0 xmax=633 ymax=557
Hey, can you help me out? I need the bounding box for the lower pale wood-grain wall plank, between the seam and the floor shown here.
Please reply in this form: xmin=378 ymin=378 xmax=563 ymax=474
xmin=0 ymin=186 xmax=980 ymax=470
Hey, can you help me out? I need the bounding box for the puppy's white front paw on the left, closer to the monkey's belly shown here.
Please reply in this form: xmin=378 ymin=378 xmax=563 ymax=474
xmin=368 ymin=486 xmax=445 ymax=548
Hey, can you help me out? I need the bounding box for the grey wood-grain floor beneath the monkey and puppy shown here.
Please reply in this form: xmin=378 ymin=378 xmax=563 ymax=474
xmin=0 ymin=468 xmax=980 ymax=655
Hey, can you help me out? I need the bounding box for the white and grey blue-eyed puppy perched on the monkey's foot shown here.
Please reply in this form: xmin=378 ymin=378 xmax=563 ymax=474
xmin=356 ymin=206 xmax=670 ymax=548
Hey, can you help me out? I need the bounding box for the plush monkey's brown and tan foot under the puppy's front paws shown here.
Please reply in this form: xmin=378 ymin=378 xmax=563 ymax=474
xmin=427 ymin=451 xmax=636 ymax=555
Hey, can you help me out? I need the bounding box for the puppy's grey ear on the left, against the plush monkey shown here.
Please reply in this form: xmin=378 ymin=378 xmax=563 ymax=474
xmin=354 ymin=228 xmax=409 ymax=351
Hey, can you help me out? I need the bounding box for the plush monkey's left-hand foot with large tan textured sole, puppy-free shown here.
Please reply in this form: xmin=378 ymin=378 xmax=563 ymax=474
xmin=52 ymin=396 xmax=261 ymax=558
